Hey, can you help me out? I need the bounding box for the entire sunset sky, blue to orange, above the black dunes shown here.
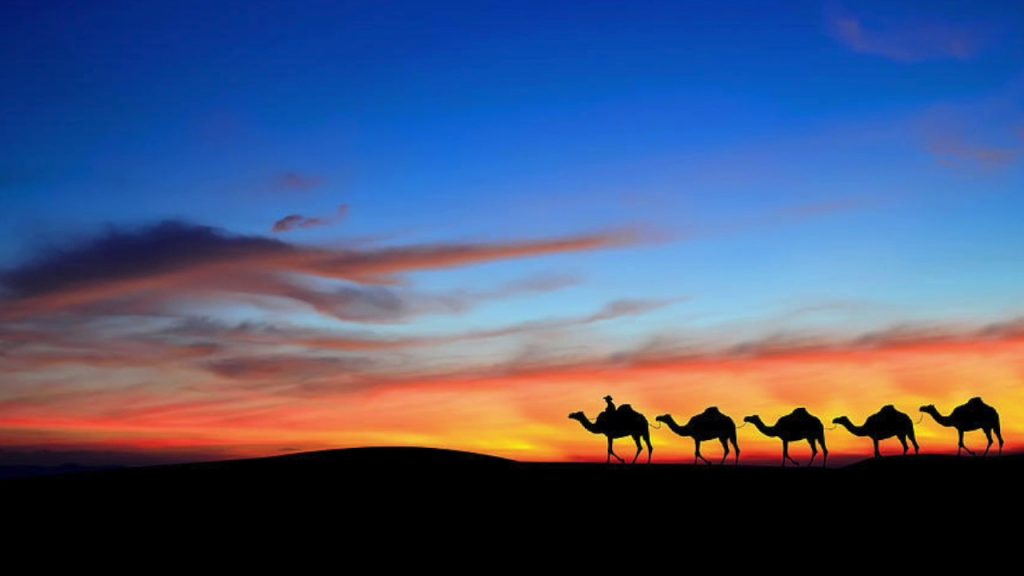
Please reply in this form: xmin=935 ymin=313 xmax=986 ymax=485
xmin=0 ymin=1 xmax=1024 ymax=464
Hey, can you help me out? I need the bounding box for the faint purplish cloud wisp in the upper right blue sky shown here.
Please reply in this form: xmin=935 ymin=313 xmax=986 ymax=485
xmin=825 ymin=4 xmax=984 ymax=63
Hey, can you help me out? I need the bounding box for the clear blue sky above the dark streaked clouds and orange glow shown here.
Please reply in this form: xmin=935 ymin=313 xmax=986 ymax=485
xmin=0 ymin=2 xmax=1024 ymax=385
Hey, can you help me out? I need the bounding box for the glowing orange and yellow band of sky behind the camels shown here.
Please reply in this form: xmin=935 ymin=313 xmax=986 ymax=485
xmin=0 ymin=330 xmax=1024 ymax=462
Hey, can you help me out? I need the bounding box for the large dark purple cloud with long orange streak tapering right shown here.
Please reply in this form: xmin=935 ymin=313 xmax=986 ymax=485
xmin=0 ymin=221 xmax=639 ymax=320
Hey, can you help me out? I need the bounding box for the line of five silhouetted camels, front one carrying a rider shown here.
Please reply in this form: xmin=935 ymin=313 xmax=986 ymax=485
xmin=569 ymin=396 xmax=1004 ymax=466
